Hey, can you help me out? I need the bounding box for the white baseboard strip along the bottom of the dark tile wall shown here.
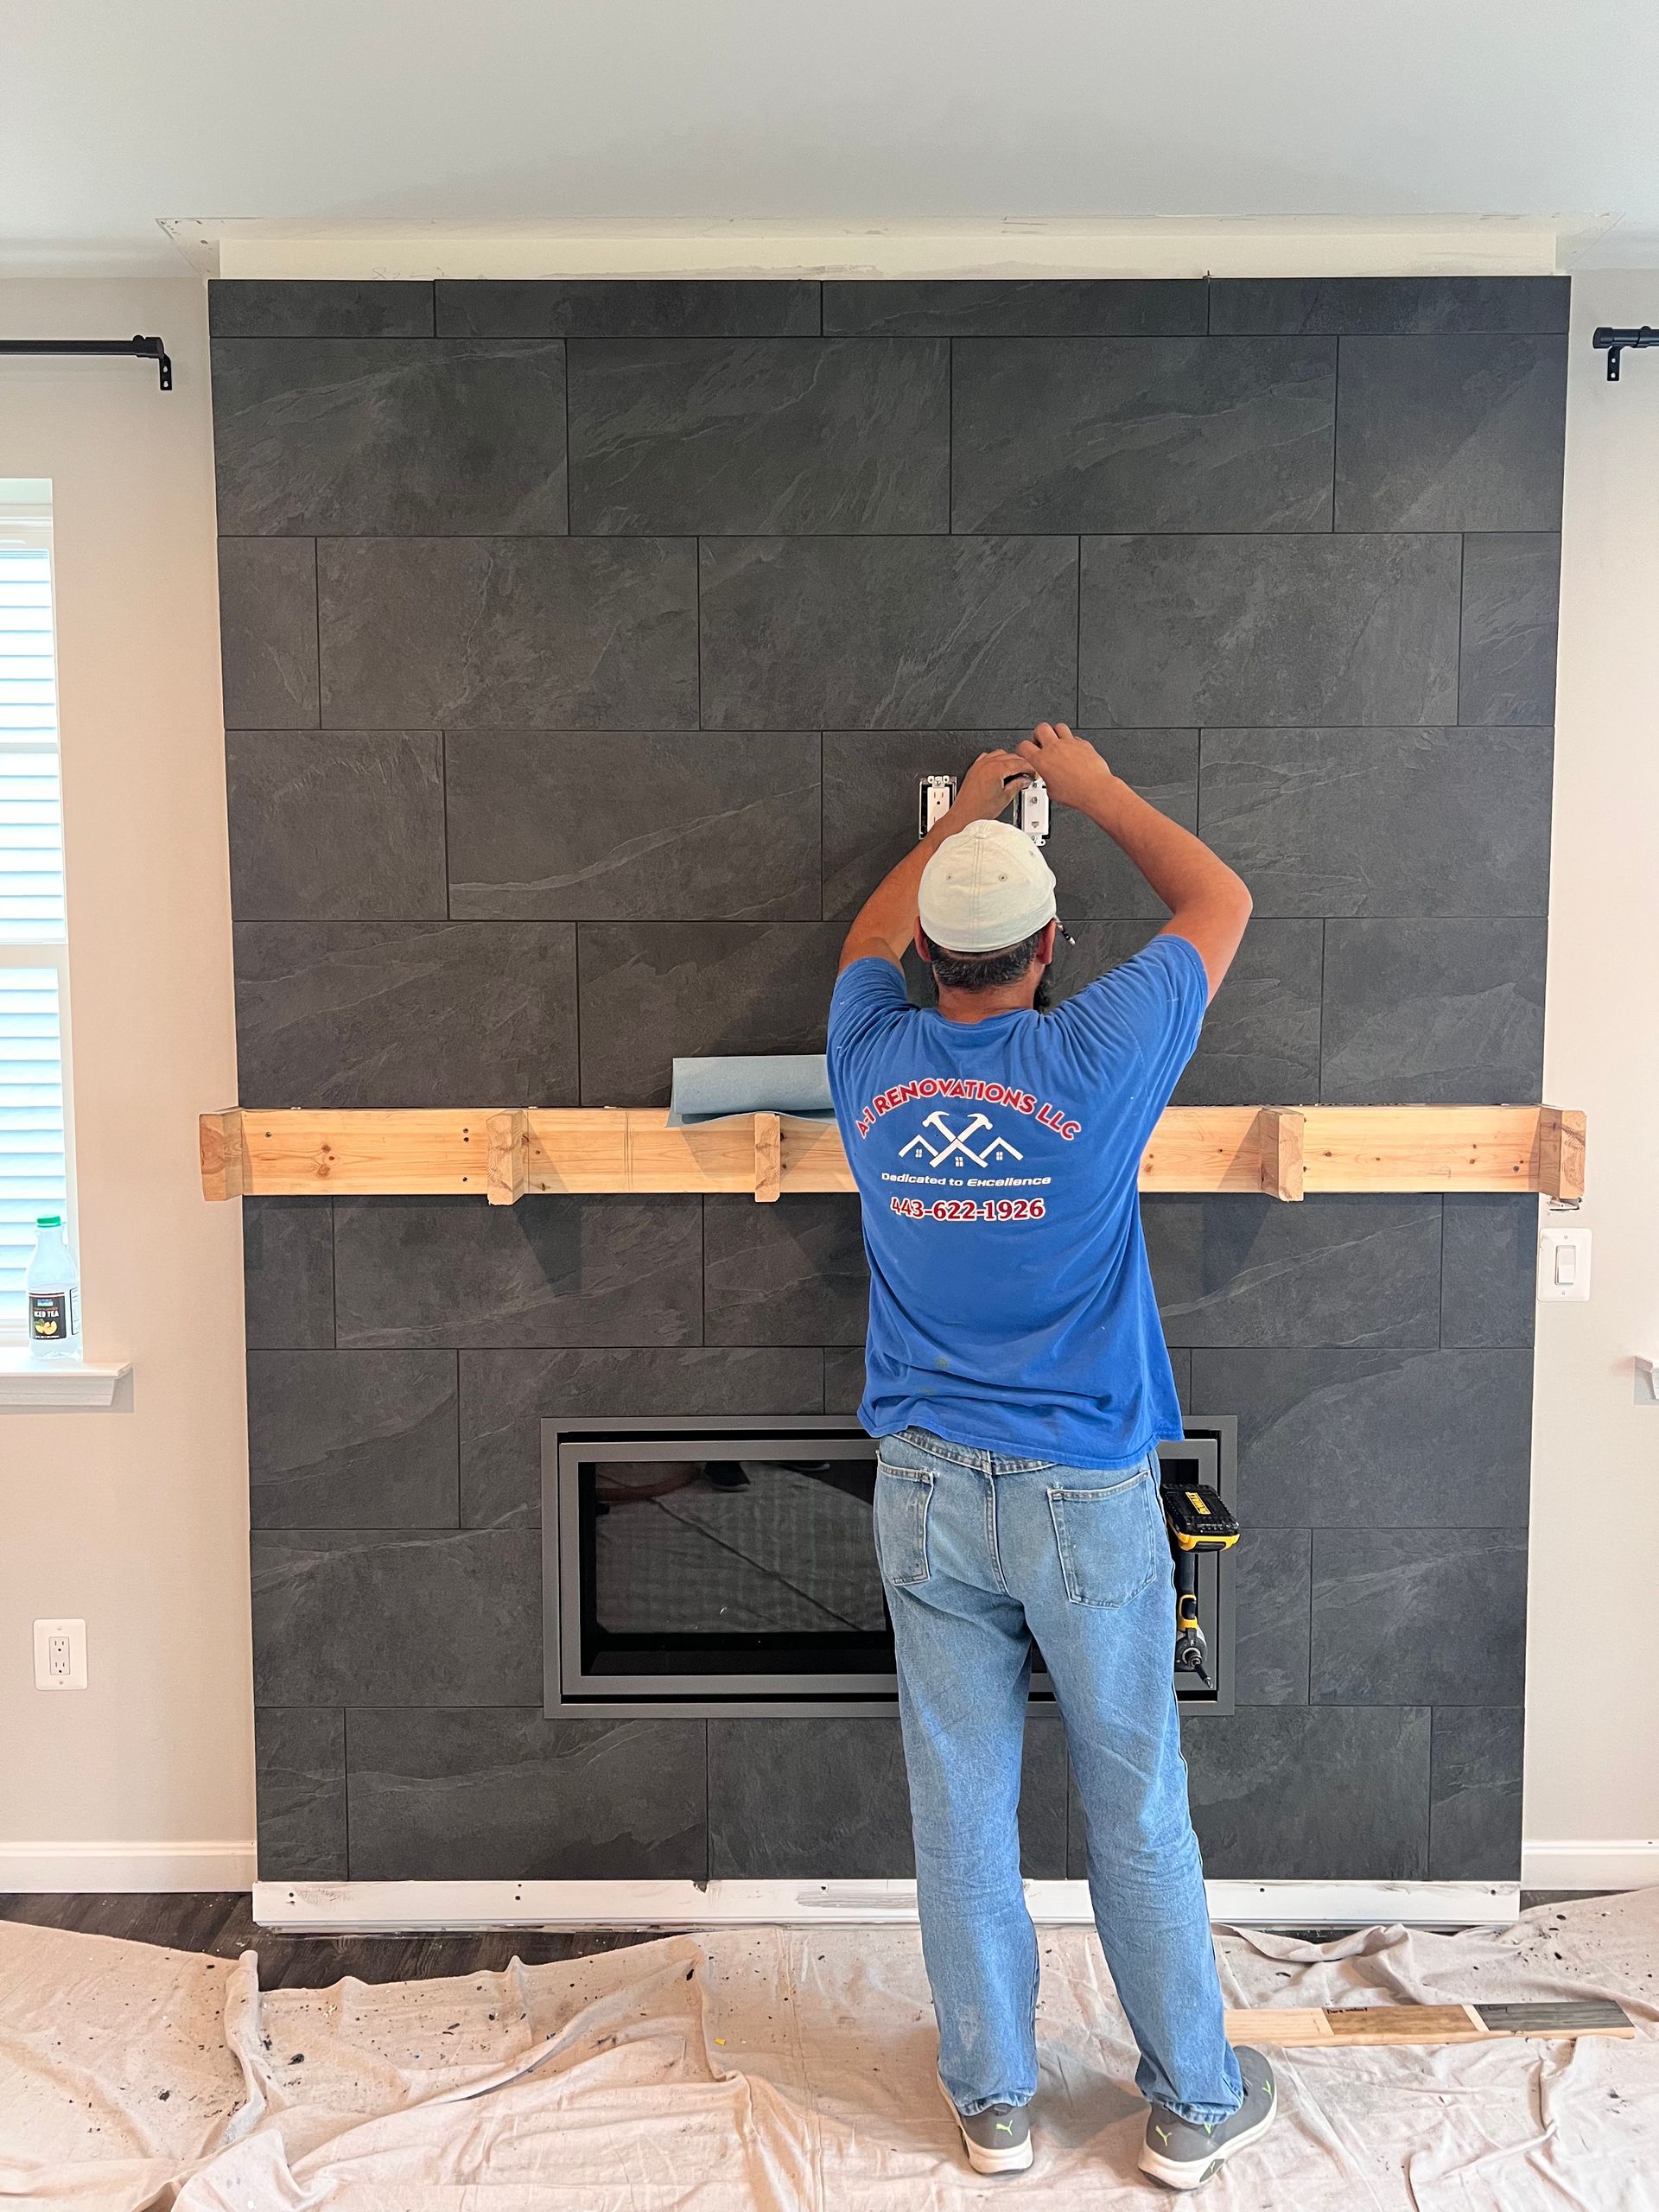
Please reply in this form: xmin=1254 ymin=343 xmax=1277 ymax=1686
xmin=254 ymin=1883 xmax=1520 ymax=1933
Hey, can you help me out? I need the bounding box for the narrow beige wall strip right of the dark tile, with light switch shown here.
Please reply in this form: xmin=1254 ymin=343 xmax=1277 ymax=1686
xmin=1526 ymin=270 xmax=1659 ymax=1887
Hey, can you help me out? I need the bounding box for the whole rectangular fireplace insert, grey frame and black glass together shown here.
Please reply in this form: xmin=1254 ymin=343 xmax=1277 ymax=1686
xmin=542 ymin=1414 xmax=1236 ymax=1717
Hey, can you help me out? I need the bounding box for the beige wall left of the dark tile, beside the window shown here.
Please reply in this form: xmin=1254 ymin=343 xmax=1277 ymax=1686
xmin=0 ymin=279 xmax=252 ymax=1889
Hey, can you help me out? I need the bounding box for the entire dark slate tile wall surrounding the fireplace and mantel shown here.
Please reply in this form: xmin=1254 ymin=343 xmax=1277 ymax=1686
xmin=210 ymin=279 xmax=1566 ymax=1880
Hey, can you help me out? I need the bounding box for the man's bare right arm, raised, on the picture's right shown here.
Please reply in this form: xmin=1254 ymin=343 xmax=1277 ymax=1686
xmin=1020 ymin=721 xmax=1249 ymax=998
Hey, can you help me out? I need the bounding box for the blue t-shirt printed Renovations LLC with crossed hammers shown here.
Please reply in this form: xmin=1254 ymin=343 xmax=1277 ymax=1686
xmin=830 ymin=936 xmax=1210 ymax=1469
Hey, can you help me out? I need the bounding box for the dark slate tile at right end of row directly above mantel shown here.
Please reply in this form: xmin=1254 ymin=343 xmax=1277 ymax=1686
xmin=1320 ymin=916 xmax=1544 ymax=1106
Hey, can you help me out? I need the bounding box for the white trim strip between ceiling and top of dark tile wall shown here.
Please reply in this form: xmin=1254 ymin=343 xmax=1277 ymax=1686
xmin=162 ymin=214 xmax=1615 ymax=281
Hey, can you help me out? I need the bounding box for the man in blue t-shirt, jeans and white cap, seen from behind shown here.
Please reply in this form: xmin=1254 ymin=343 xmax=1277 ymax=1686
xmin=830 ymin=723 xmax=1274 ymax=2188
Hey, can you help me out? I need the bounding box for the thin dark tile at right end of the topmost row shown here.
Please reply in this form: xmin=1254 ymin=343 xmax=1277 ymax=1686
xmin=1210 ymin=276 xmax=1568 ymax=339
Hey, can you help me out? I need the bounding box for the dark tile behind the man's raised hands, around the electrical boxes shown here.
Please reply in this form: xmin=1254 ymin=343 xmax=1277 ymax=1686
xmin=823 ymin=728 xmax=1199 ymax=925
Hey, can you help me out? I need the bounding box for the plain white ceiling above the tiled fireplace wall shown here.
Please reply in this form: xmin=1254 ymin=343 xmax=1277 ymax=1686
xmin=13 ymin=0 xmax=1659 ymax=276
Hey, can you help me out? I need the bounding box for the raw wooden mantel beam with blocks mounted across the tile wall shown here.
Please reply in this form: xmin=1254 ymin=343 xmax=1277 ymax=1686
xmin=201 ymin=1106 xmax=1584 ymax=1205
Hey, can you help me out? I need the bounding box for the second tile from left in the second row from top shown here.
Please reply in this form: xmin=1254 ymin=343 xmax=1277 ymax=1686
xmin=570 ymin=339 xmax=951 ymax=536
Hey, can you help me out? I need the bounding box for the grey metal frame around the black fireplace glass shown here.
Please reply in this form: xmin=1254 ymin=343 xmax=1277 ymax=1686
xmin=542 ymin=1414 xmax=1239 ymax=1721
